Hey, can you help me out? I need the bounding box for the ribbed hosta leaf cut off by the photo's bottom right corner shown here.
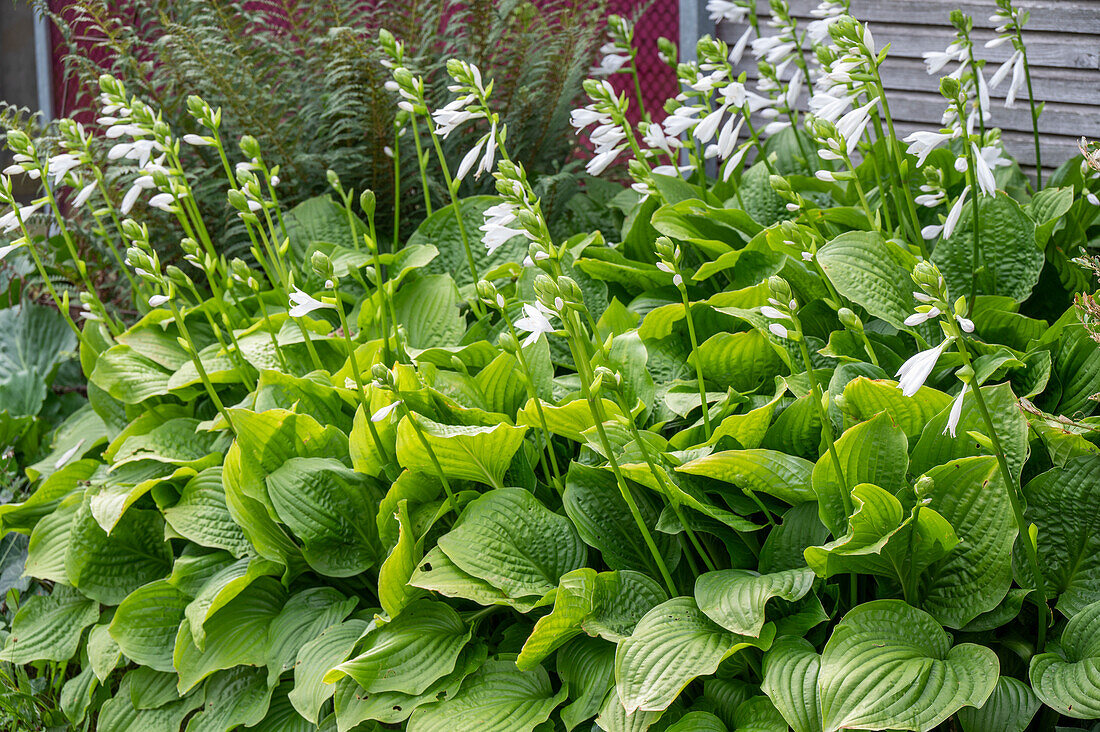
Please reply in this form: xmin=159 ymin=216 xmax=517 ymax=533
xmin=1029 ymin=602 xmax=1100 ymax=719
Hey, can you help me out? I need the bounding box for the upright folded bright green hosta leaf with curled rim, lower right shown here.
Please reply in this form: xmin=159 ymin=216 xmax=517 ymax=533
xmin=805 ymin=483 xmax=959 ymax=584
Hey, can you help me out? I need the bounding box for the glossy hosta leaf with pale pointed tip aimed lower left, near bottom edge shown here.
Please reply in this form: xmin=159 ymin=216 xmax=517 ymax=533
xmin=321 ymin=600 xmax=473 ymax=695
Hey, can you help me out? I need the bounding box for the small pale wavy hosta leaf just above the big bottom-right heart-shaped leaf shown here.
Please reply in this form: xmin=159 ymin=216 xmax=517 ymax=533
xmin=695 ymin=569 xmax=814 ymax=637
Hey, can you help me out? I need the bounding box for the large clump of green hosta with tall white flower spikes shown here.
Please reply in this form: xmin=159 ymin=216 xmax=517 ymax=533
xmin=0 ymin=0 xmax=1100 ymax=732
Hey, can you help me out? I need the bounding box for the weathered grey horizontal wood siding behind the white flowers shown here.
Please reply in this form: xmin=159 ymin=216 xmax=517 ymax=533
xmin=718 ymin=0 xmax=1100 ymax=176
